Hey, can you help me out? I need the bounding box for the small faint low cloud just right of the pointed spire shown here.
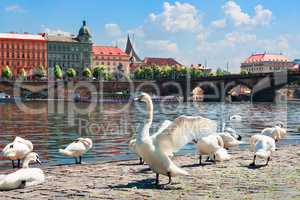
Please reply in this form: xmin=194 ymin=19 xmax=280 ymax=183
xmin=145 ymin=40 xmax=178 ymax=53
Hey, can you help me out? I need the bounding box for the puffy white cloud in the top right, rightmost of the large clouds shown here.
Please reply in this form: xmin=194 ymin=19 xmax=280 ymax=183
xmin=223 ymin=1 xmax=272 ymax=26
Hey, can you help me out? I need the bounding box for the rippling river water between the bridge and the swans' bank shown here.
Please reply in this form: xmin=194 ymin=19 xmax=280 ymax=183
xmin=0 ymin=101 xmax=300 ymax=170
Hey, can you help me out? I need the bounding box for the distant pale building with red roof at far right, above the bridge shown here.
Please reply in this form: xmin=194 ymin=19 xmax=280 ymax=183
xmin=241 ymin=53 xmax=294 ymax=73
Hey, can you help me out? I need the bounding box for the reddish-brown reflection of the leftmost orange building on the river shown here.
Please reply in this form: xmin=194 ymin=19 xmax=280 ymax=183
xmin=0 ymin=102 xmax=49 ymax=166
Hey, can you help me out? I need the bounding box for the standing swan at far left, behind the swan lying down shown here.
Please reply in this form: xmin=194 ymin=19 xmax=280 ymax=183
xmin=2 ymin=137 xmax=33 ymax=168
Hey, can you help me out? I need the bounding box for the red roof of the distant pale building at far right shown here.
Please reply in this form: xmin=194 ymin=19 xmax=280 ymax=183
xmin=243 ymin=53 xmax=290 ymax=63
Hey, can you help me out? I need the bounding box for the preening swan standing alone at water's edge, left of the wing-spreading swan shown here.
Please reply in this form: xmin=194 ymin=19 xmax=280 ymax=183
xmin=59 ymin=138 xmax=93 ymax=164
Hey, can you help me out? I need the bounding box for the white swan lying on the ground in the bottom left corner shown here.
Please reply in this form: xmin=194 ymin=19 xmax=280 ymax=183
xmin=0 ymin=152 xmax=45 ymax=191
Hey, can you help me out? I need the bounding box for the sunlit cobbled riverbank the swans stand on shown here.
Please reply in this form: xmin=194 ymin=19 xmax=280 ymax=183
xmin=0 ymin=145 xmax=300 ymax=200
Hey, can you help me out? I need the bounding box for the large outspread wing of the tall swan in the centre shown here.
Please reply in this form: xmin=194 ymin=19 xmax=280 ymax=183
xmin=153 ymin=116 xmax=217 ymax=155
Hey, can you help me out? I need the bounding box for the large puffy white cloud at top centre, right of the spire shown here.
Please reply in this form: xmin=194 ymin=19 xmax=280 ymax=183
xmin=149 ymin=2 xmax=200 ymax=32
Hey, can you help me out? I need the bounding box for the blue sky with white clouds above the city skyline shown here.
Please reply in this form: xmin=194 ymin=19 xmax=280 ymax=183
xmin=0 ymin=0 xmax=300 ymax=72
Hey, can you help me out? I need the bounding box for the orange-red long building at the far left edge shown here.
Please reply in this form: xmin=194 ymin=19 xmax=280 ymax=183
xmin=0 ymin=32 xmax=48 ymax=76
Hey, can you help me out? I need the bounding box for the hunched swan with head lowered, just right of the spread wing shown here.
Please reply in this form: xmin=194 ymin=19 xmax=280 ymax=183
xmin=196 ymin=134 xmax=231 ymax=165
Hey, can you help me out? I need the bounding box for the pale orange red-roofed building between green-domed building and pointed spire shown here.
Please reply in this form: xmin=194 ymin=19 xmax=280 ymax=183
xmin=93 ymin=46 xmax=130 ymax=74
